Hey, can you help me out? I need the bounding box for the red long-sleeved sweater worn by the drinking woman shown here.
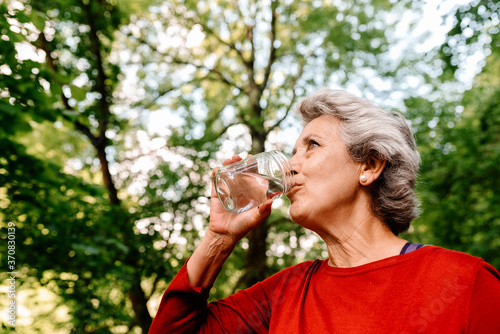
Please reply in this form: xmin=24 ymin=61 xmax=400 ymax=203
xmin=149 ymin=246 xmax=500 ymax=334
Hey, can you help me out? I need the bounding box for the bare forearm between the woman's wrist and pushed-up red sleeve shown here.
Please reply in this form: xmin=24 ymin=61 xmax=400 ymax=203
xmin=186 ymin=229 xmax=236 ymax=287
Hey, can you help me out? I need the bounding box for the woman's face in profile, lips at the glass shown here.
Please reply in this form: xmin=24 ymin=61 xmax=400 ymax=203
xmin=287 ymin=115 xmax=361 ymax=232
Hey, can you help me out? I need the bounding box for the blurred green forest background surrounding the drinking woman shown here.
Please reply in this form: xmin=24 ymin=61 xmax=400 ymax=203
xmin=0 ymin=0 xmax=500 ymax=334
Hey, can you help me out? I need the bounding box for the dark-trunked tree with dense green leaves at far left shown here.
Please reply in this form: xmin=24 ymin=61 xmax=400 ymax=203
xmin=0 ymin=0 xmax=159 ymax=333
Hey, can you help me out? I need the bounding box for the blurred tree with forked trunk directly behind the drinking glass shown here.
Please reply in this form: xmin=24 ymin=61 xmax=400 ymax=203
xmin=124 ymin=0 xmax=414 ymax=287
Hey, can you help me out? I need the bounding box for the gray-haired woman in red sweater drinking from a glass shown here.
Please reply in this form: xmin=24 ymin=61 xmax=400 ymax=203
xmin=150 ymin=89 xmax=500 ymax=334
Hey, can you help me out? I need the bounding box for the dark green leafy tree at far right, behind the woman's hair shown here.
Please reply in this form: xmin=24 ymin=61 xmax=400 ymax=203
xmin=407 ymin=1 xmax=500 ymax=268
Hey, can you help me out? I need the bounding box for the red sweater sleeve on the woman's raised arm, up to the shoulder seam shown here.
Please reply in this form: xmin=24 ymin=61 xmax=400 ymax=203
xmin=149 ymin=264 xmax=279 ymax=334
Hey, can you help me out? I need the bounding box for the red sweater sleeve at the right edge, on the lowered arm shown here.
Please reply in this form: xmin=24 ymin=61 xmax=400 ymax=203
xmin=468 ymin=261 xmax=500 ymax=334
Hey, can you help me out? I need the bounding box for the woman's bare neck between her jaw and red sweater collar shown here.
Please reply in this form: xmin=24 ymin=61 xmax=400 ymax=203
xmin=320 ymin=216 xmax=406 ymax=268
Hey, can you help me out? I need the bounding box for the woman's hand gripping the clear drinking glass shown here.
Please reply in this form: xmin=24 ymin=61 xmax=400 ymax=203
xmin=207 ymin=155 xmax=272 ymax=245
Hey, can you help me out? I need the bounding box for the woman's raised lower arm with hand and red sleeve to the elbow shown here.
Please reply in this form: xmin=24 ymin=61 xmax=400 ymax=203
xmin=149 ymin=156 xmax=272 ymax=334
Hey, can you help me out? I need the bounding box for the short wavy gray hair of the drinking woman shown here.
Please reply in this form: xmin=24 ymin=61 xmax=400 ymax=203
xmin=297 ymin=88 xmax=420 ymax=235
